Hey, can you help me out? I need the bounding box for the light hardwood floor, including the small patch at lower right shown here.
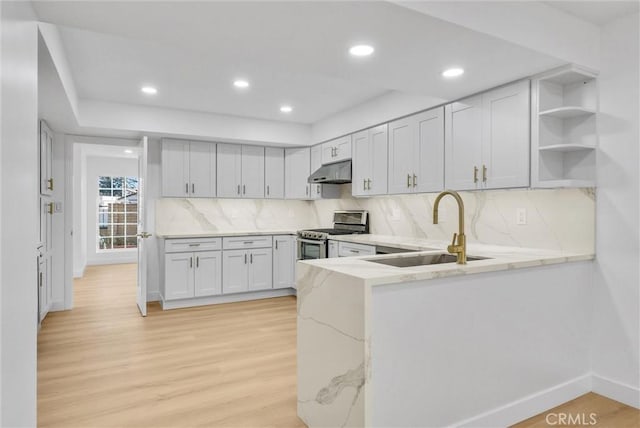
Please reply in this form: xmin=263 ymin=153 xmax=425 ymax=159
xmin=38 ymin=265 xmax=640 ymax=428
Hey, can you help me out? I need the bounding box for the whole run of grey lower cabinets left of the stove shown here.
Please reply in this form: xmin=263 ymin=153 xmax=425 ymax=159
xmin=161 ymin=235 xmax=296 ymax=309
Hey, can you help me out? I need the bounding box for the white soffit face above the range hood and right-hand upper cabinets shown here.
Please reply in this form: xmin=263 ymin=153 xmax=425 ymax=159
xmin=311 ymin=91 xmax=446 ymax=143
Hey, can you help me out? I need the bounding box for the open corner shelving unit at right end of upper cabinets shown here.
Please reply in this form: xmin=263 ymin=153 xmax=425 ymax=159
xmin=531 ymin=65 xmax=598 ymax=188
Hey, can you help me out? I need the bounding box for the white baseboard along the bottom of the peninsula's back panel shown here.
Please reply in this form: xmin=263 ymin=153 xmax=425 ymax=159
xmin=452 ymin=374 xmax=591 ymax=427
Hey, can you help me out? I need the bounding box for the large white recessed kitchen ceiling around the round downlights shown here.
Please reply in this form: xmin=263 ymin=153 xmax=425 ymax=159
xmin=34 ymin=1 xmax=562 ymax=123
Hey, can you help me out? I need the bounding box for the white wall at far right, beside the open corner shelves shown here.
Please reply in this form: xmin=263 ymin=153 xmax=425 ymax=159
xmin=592 ymin=14 xmax=640 ymax=407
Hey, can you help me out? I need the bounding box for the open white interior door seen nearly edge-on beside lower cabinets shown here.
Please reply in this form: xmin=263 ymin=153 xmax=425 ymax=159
xmin=136 ymin=137 xmax=151 ymax=317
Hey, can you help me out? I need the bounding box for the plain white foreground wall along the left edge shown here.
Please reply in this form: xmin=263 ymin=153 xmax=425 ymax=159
xmin=0 ymin=2 xmax=39 ymax=427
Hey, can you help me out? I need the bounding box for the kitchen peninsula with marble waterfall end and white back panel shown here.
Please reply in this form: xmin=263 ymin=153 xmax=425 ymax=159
xmin=296 ymin=235 xmax=594 ymax=427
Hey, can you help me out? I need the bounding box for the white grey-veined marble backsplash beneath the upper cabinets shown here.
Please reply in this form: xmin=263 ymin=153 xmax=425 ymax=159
xmin=156 ymin=185 xmax=595 ymax=252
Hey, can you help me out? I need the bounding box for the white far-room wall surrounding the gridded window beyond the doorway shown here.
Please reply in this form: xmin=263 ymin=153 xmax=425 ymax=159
xmin=84 ymin=156 xmax=138 ymax=265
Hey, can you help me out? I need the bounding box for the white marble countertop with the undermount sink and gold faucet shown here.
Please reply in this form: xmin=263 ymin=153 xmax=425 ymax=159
xmin=299 ymin=235 xmax=594 ymax=286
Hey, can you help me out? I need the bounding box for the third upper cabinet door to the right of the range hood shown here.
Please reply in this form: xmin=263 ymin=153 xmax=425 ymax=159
xmin=389 ymin=118 xmax=415 ymax=194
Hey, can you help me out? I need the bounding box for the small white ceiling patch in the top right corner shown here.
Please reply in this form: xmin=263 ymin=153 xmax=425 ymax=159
xmin=544 ymin=0 xmax=640 ymax=26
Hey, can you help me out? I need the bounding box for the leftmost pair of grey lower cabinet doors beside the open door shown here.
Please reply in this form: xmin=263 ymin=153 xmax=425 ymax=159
xmin=164 ymin=251 xmax=222 ymax=300
